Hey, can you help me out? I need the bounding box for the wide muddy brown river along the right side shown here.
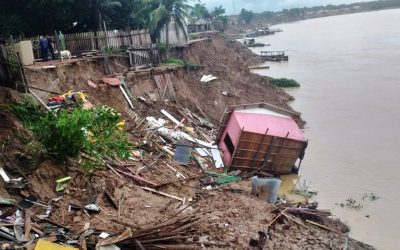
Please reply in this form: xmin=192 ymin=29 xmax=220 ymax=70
xmin=248 ymin=9 xmax=400 ymax=249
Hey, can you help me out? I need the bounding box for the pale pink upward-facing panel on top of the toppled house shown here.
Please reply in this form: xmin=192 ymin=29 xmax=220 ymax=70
xmin=232 ymin=109 xmax=305 ymax=141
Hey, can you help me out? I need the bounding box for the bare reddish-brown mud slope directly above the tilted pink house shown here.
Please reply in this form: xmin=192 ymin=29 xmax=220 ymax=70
xmin=167 ymin=35 xmax=292 ymax=118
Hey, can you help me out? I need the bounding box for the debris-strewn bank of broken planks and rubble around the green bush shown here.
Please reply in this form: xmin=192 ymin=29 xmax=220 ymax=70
xmin=0 ymin=36 xmax=372 ymax=250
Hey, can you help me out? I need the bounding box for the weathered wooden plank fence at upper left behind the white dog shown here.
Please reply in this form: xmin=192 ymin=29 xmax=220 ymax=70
xmin=28 ymin=30 xmax=152 ymax=58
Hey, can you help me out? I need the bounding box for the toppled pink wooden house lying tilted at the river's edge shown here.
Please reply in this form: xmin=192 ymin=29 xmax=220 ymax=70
xmin=217 ymin=103 xmax=307 ymax=174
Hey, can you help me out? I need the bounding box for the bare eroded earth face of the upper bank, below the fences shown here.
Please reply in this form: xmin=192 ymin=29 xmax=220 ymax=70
xmin=26 ymin=35 xmax=292 ymax=124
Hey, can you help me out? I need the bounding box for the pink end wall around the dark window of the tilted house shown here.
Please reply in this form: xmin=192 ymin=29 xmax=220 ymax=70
xmin=218 ymin=115 xmax=242 ymax=166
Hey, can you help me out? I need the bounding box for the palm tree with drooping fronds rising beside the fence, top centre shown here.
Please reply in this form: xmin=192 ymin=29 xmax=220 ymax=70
xmin=149 ymin=0 xmax=191 ymax=54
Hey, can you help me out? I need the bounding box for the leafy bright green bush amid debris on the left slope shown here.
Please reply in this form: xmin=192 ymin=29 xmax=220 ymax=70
xmin=34 ymin=106 xmax=131 ymax=170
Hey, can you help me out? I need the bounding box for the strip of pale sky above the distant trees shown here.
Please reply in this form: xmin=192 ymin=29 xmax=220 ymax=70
xmin=195 ymin=0 xmax=371 ymax=14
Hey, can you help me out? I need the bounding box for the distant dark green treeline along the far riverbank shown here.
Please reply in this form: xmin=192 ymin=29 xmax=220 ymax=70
xmin=244 ymin=0 xmax=400 ymax=24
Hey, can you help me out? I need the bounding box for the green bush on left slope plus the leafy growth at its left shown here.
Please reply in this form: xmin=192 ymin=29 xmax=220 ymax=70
xmin=9 ymin=99 xmax=131 ymax=171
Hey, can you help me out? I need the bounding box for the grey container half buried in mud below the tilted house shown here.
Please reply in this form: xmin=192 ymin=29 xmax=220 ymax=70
xmin=251 ymin=176 xmax=282 ymax=204
